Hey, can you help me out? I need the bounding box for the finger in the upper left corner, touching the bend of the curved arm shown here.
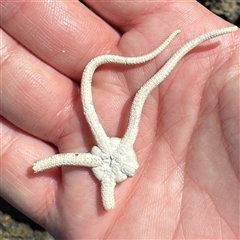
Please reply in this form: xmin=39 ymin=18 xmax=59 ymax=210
xmin=1 ymin=1 xmax=119 ymax=79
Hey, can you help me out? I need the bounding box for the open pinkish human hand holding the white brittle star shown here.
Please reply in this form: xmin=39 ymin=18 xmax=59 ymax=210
xmin=0 ymin=1 xmax=239 ymax=239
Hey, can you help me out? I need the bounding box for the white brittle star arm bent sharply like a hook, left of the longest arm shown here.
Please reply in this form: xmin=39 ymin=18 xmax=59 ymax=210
xmin=81 ymin=30 xmax=180 ymax=153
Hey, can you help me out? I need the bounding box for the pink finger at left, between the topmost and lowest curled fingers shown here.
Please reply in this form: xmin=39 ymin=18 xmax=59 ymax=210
xmin=0 ymin=31 xmax=91 ymax=149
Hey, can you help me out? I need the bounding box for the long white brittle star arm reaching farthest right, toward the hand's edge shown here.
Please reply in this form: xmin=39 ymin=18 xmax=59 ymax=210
xmin=118 ymin=26 xmax=238 ymax=152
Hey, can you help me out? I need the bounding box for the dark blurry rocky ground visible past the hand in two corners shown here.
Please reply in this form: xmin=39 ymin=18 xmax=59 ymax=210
xmin=0 ymin=0 xmax=240 ymax=240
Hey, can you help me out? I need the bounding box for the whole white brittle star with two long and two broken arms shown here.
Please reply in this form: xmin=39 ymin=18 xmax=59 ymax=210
xmin=33 ymin=26 xmax=238 ymax=210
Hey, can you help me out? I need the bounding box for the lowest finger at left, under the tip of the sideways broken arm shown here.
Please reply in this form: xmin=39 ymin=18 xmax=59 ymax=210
xmin=0 ymin=117 xmax=61 ymax=224
